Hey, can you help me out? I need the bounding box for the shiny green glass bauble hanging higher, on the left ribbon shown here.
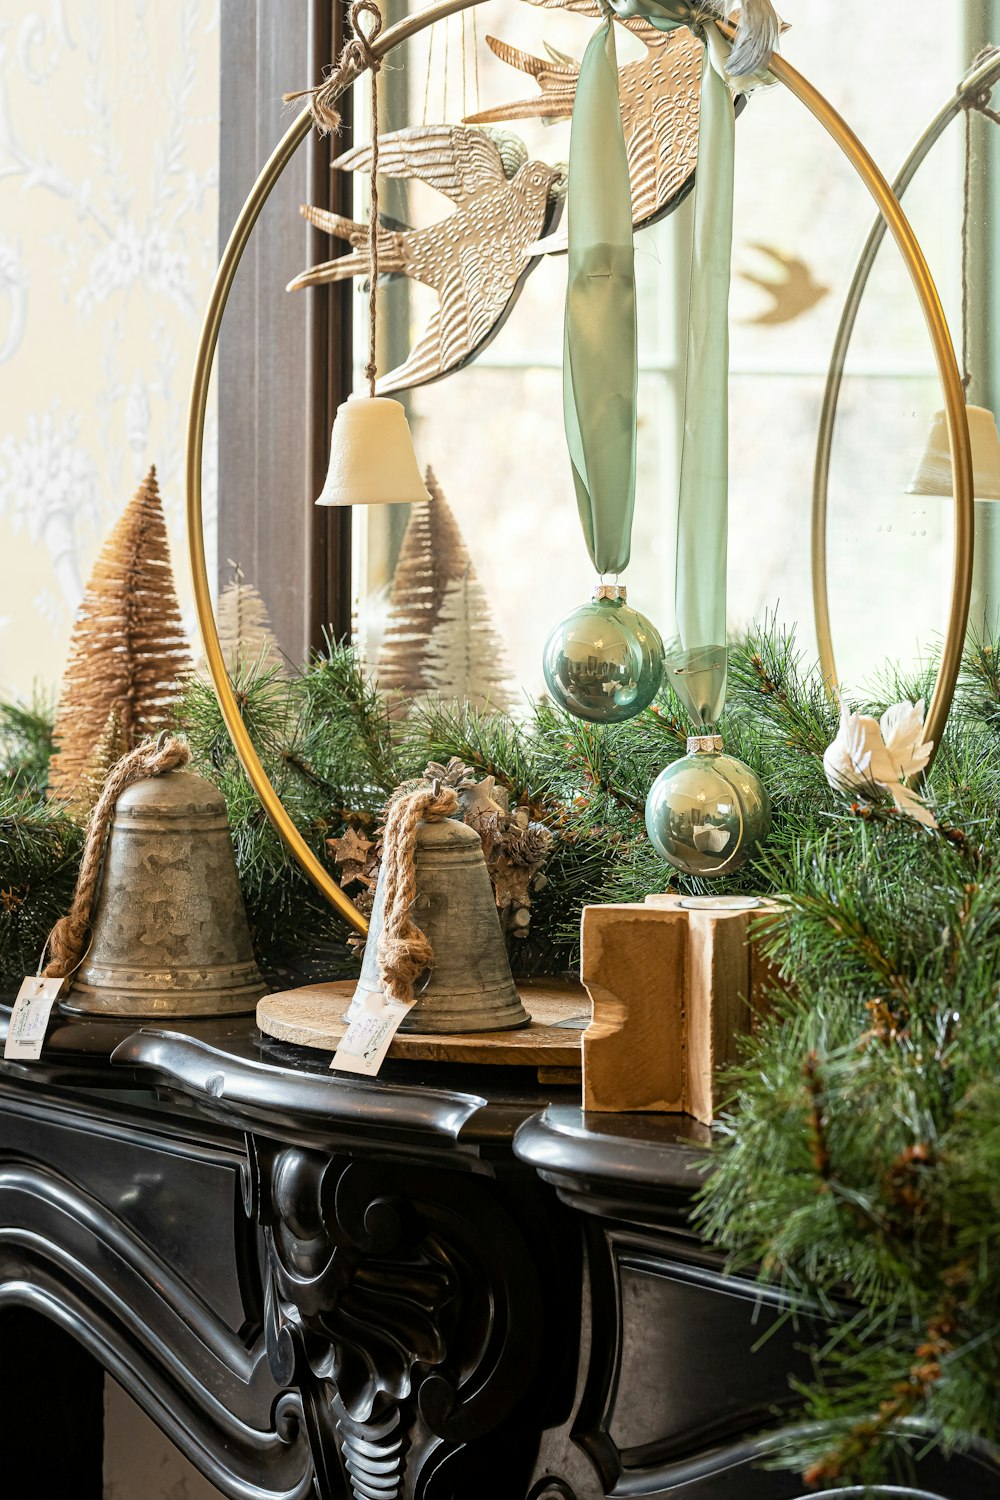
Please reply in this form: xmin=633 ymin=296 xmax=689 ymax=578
xmin=541 ymin=587 xmax=663 ymax=725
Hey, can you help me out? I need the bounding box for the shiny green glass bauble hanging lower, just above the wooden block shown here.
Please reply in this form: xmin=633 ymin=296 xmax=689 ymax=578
xmin=646 ymin=735 xmax=771 ymax=876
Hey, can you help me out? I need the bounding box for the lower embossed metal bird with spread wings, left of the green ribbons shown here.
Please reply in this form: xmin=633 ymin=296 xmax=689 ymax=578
xmin=288 ymin=125 xmax=565 ymax=395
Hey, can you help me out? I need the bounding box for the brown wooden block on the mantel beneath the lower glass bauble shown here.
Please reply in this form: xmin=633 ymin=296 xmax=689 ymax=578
xmin=580 ymin=896 xmax=778 ymax=1125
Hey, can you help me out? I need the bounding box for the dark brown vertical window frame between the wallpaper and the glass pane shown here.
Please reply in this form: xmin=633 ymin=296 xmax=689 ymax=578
xmin=217 ymin=0 xmax=351 ymax=662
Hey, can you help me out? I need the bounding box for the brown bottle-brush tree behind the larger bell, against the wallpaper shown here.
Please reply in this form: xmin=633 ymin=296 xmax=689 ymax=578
xmin=48 ymin=468 xmax=190 ymax=804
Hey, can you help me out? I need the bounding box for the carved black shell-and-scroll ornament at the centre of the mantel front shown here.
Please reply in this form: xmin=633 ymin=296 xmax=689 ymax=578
xmin=247 ymin=1139 xmax=543 ymax=1500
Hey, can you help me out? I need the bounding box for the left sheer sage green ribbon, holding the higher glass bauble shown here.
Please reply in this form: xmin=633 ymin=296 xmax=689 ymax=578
xmin=562 ymin=15 xmax=639 ymax=573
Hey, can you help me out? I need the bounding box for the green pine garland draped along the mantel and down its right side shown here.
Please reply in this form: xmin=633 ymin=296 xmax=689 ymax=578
xmin=0 ymin=624 xmax=1000 ymax=1488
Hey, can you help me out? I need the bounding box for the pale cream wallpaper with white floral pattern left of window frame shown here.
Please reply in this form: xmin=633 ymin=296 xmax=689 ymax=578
xmin=0 ymin=0 xmax=219 ymax=696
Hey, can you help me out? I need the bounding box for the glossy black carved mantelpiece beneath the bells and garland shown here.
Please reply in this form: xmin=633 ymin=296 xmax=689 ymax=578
xmin=0 ymin=1013 xmax=1000 ymax=1500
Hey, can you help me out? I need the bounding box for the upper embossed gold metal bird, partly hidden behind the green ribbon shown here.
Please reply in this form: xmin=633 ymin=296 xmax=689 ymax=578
xmin=468 ymin=0 xmax=703 ymax=237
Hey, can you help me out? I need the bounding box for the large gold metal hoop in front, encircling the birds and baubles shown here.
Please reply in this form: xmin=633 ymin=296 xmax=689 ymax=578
xmin=187 ymin=0 xmax=973 ymax=933
